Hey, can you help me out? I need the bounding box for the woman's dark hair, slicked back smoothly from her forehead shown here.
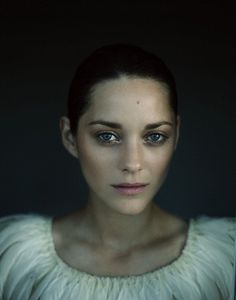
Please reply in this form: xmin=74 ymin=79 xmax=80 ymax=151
xmin=68 ymin=44 xmax=177 ymax=134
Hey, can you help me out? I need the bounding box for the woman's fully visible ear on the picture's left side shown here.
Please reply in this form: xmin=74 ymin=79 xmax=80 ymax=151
xmin=59 ymin=117 xmax=79 ymax=158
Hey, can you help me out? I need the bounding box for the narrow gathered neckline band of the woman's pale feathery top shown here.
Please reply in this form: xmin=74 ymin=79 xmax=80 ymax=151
xmin=46 ymin=217 xmax=195 ymax=280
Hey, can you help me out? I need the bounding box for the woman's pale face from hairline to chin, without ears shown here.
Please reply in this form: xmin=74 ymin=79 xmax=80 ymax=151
xmin=71 ymin=77 xmax=179 ymax=215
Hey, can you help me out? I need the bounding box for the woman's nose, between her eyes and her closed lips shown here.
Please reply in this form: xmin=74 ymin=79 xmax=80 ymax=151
xmin=120 ymin=142 xmax=143 ymax=173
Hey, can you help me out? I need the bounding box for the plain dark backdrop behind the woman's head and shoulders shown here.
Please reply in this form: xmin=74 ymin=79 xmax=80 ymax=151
xmin=0 ymin=0 xmax=236 ymax=217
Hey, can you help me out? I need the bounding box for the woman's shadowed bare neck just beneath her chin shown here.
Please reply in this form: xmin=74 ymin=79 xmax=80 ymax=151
xmin=85 ymin=191 xmax=162 ymax=251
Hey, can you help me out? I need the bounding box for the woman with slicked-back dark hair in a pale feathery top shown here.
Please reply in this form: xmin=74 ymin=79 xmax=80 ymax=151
xmin=0 ymin=45 xmax=235 ymax=300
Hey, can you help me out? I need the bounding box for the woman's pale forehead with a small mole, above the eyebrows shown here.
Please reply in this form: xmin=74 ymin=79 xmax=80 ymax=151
xmin=80 ymin=76 xmax=173 ymax=122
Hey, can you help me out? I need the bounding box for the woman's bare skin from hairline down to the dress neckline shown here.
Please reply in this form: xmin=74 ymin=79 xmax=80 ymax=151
xmin=53 ymin=77 xmax=187 ymax=276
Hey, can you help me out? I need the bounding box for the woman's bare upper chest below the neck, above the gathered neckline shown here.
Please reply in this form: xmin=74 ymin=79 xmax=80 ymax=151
xmin=55 ymin=214 xmax=187 ymax=277
